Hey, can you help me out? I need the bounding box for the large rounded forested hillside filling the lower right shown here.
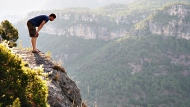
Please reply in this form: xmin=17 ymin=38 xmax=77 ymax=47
xmin=68 ymin=35 xmax=190 ymax=107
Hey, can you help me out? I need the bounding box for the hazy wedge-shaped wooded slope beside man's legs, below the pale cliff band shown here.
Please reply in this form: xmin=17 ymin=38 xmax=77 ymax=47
xmin=38 ymin=34 xmax=108 ymax=68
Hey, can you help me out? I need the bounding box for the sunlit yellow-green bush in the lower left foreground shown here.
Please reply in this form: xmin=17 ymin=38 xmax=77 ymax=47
xmin=0 ymin=44 xmax=48 ymax=107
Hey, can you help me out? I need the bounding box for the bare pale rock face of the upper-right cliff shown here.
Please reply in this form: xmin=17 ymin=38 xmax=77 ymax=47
xmin=149 ymin=5 xmax=190 ymax=39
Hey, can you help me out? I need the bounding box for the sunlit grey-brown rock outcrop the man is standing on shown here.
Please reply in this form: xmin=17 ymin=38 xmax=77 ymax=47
xmin=12 ymin=48 xmax=82 ymax=107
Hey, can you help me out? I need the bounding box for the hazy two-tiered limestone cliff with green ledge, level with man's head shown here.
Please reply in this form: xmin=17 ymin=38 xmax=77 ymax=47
xmin=24 ymin=12 xmax=138 ymax=40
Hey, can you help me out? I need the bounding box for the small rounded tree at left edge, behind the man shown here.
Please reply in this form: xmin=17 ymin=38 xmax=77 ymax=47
xmin=0 ymin=20 xmax=18 ymax=47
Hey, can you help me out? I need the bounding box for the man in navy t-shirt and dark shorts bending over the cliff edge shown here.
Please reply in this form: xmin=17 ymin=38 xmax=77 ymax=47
xmin=27 ymin=13 xmax=56 ymax=53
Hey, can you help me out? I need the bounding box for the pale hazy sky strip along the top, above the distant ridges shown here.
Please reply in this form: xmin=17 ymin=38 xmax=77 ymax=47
xmin=0 ymin=0 xmax=132 ymax=17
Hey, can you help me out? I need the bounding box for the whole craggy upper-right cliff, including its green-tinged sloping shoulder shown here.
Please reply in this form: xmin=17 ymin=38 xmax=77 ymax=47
xmin=133 ymin=4 xmax=190 ymax=39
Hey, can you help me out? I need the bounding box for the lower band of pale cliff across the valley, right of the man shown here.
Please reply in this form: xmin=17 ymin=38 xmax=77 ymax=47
xmin=42 ymin=24 xmax=128 ymax=40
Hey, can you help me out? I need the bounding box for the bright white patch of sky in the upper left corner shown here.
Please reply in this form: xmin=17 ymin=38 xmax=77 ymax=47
xmin=0 ymin=0 xmax=48 ymax=17
